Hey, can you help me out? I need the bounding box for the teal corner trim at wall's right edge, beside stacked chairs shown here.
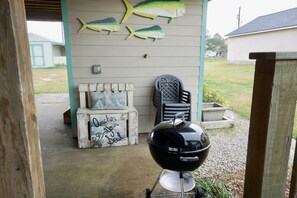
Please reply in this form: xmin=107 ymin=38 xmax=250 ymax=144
xmin=197 ymin=0 xmax=208 ymax=121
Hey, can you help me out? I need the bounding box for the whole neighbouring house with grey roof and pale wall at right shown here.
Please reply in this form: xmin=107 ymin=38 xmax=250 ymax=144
xmin=226 ymin=8 xmax=297 ymax=63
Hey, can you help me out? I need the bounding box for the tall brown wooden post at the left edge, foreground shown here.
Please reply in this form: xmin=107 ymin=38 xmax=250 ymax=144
xmin=0 ymin=0 xmax=45 ymax=198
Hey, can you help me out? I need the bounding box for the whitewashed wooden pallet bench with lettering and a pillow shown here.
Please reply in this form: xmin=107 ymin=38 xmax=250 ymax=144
xmin=77 ymin=83 xmax=138 ymax=148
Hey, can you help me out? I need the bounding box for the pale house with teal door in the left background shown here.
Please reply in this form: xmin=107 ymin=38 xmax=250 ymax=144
xmin=29 ymin=33 xmax=66 ymax=67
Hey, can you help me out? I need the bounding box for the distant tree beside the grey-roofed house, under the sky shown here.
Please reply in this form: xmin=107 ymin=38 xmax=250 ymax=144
xmin=206 ymin=33 xmax=227 ymax=56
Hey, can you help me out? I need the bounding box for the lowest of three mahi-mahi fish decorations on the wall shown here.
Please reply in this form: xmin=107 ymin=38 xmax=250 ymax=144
xmin=126 ymin=25 xmax=165 ymax=41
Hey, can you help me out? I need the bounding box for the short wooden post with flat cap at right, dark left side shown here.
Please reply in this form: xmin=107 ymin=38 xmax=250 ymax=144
xmin=244 ymin=53 xmax=297 ymax=198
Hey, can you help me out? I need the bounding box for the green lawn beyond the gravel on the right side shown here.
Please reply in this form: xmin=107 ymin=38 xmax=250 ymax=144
xmin=204 ymin=58 xmax=297 ymax=137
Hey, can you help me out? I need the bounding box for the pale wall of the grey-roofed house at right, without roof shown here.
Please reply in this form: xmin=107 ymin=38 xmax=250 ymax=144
xmin=227 ymin=28 xmax=297 ymax=63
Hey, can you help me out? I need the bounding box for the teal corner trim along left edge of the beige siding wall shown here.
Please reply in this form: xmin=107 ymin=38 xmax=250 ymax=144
xmin=61 ymin=0 xmax=76 ymax=128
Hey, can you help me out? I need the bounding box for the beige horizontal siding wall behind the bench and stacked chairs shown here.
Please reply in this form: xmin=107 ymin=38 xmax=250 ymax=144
xmin=67 ymin=0 xmax=202 ymax=132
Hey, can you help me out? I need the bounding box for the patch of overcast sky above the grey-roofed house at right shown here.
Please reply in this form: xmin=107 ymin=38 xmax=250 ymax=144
xmin=207 ymin=0 xmax=297 ymax=37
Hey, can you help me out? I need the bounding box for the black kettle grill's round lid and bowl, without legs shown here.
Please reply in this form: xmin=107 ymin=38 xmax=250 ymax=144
xmin=147 ymin=115 xmax=210 ymax=171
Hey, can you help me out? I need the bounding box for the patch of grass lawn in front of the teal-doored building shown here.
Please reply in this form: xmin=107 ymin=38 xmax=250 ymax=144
xmin=32 ymin=66 xmax=68 ymax=94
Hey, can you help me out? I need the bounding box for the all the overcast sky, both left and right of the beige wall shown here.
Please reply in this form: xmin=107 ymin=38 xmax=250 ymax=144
xmin=27 ymin=0 xmax=297 ymax=42
